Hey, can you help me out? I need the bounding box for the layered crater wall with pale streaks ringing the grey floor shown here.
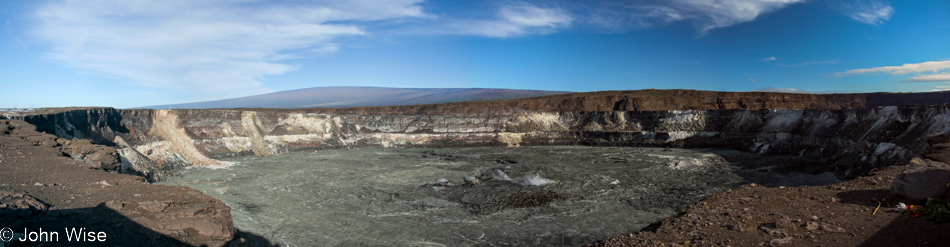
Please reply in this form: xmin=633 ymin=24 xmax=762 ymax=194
xmin=7 ymin=90 xmax=950 ymax=180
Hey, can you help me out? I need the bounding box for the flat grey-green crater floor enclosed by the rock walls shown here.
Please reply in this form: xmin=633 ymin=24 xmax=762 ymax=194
xmin=165 ymin=146 xmax=839 ymax=246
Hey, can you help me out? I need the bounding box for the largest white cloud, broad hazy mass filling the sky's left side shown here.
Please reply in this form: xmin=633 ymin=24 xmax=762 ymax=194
xmin=31 ymin=0 xmax=425 ymax=93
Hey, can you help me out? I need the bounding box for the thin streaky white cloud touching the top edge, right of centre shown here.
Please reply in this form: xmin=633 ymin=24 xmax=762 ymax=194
xmin=587 ymin=0 xmax=805 ymax=35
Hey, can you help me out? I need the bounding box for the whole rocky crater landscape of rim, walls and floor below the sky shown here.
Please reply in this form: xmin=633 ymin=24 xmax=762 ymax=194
xmin=0 ymin=90 xmax=950 ymax=246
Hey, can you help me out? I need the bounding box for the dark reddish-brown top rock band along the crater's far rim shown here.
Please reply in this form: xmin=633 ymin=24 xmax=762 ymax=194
xmin=284 ymin=90 xmax=950 ymax=114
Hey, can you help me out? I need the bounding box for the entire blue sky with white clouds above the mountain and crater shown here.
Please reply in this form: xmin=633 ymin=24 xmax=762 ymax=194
xmin=0 ymin=0 xmax=950 ymax=108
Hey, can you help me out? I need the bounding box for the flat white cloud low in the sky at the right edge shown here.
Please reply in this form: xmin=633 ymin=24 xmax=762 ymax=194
xmin=834 ymin=60 xmax=950 ymax=82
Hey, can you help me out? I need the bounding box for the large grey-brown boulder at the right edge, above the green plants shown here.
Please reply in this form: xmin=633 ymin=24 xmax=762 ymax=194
xmin=891 ymin=158 xmax=950 ymax=200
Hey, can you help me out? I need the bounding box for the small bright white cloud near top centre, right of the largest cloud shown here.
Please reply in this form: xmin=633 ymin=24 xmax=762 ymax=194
xmin=441 ymin=3 xmax=574 ymax=38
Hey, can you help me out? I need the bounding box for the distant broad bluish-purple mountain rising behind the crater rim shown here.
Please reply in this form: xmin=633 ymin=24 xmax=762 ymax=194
xmin=139 ymin=87 xmax=571 ymax=109
